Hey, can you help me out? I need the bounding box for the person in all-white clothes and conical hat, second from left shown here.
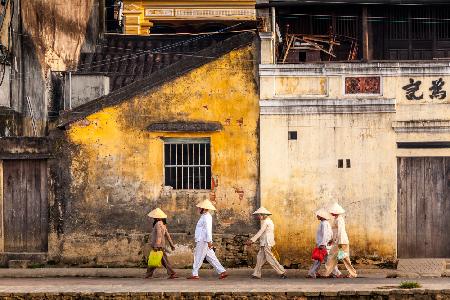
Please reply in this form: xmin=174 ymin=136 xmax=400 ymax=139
xmin=188 ymin=200 xmax=228 ymax=279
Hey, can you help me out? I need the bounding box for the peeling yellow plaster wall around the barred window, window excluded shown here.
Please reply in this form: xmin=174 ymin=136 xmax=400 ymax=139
xmin=49 ymin=46 xmax=259 ymax=266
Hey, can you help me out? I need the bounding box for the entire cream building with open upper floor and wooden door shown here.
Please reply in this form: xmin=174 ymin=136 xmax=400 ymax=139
xmin=257 ymin=1 xmax=450 ymax=264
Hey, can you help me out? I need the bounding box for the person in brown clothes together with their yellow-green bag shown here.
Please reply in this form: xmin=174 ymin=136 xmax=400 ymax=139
xmin=145 ymin=208 xmax=178 ymax=279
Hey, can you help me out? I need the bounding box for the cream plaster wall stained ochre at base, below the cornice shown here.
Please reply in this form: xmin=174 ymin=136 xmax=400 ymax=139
xmin=261 ymin=113 xmax=397 ymax=264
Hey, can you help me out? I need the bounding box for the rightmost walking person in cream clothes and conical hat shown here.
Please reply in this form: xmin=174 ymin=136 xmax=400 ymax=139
xmin=324 ymin=203 xmax=358 ymax=278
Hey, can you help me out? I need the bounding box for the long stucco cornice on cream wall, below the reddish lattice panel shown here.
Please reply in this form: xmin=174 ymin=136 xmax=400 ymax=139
xmin=259 ymin=99 xmax=395 ymax=115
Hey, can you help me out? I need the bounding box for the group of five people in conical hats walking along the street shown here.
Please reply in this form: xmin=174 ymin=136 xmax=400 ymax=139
xmin=146 ymin=200 xmax=357 ymax=280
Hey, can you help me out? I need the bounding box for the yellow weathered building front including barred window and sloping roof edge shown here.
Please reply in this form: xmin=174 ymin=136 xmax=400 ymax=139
xmin=49 ymin=33 xmax=259 ymax=267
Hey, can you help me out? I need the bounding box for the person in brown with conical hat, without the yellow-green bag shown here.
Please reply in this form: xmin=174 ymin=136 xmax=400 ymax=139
xmin=145 ymin=208 xmax=178 ymax=279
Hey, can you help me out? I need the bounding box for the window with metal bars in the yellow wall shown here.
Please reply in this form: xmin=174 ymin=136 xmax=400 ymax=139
xmin=164 ymin=139 xmax=211 ymax=190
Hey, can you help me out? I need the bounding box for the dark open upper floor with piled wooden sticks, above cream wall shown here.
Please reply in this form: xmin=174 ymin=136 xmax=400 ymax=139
xmin=276 ymin=5 xmax=450 ymax=63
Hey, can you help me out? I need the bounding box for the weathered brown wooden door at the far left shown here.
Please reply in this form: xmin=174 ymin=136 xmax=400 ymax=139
xmin=3 ymin=160 xmax=48 ymax=252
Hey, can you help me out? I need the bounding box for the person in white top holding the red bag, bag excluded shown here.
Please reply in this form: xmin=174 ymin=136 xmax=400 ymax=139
xmin=306 ymin=208 xmax=341 ymax=278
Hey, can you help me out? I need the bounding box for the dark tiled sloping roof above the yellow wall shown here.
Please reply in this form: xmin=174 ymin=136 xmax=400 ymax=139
xmin=77 ymin=34 xmax=230 ymax=90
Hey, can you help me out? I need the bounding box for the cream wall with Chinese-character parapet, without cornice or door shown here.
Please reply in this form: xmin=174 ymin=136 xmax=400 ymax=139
xmin=260 ymin=72 xmax=450 ymax=263
